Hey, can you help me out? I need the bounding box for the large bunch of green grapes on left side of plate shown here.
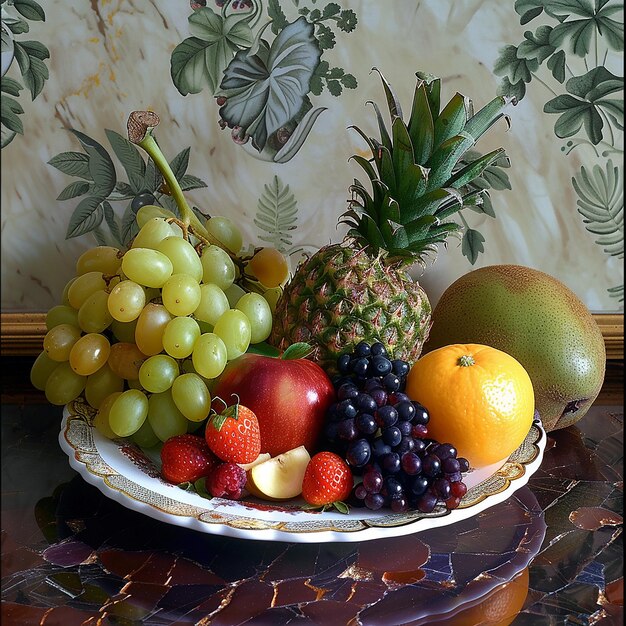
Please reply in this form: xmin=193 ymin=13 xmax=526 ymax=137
xmin=31 ymin=211 xmax=288 ymax=447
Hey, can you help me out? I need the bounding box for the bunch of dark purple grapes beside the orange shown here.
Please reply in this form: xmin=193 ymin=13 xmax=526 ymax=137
xmin=324 ymin=341 xmax=469 ymax=513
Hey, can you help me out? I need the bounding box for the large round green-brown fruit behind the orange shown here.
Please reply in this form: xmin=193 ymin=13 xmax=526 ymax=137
xmin=424 ymin=265 xmax=606 ymax=431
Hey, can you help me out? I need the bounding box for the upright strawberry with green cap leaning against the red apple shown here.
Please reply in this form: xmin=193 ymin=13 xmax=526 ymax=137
xmin=204 ymin=403 xmax=261 ymax=463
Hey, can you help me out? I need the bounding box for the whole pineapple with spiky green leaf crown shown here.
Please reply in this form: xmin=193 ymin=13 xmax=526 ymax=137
xmin=270 ymin=68 xmax=515 ymax=373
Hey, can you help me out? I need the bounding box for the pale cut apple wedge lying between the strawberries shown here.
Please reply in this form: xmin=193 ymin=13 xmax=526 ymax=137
xmin=246 ymin=446 xmax=311 ymax=501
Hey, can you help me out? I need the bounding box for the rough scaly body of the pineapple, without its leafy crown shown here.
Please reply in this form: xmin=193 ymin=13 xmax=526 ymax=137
xmin=270 ymin=242 xmax=431 ymax=374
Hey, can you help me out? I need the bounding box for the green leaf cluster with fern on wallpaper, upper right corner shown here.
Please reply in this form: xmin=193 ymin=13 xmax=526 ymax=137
xmin=494 ymin=0 xmax=624 ymax=302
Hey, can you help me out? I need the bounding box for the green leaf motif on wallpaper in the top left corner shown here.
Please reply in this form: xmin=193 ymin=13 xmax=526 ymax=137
xmin=0 ymin=0 xmax=50 ymax=148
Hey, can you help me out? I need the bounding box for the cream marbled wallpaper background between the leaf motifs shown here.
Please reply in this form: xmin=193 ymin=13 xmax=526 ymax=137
xmin=2 ymin=0 xmax=623 ymax=312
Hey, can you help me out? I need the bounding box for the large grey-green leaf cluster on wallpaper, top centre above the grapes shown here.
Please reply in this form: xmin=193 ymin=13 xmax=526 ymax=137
xmin=170 ymin=0 xmax=358 ymax=163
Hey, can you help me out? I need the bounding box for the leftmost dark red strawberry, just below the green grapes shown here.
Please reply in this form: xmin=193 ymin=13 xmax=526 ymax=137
xmin=161 ymin=434 xmax=219 ymax=485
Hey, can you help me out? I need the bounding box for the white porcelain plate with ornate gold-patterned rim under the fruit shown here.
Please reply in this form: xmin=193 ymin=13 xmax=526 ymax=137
xmin=59 ymin=399 xmax=546 ymax=543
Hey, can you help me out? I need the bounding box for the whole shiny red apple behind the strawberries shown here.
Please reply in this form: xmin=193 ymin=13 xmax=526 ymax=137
xmin=211 ymin=353 xmax=335 ymax=456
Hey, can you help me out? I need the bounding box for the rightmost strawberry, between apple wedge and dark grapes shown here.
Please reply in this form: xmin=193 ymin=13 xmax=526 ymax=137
xmin=302 ymin=452 xmax=354 ymax=512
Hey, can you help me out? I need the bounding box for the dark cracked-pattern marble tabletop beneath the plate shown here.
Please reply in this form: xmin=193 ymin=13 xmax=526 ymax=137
xmin=2 ymin=404 xmax=623 ymax=626
